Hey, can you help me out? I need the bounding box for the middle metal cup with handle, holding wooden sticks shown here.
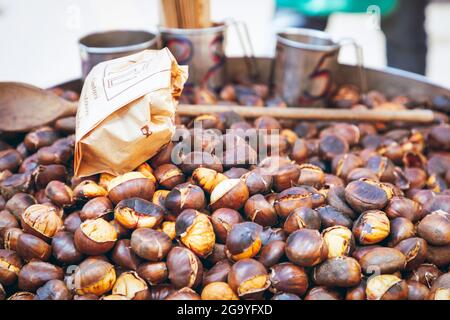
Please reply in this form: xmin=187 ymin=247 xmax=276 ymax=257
xmin=159 ymin=20 xmax=258 ymax=91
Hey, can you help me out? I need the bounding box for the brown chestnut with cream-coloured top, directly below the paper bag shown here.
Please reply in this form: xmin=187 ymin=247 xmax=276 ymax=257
xmin=108 ymin=172 xmax=155 ymax=204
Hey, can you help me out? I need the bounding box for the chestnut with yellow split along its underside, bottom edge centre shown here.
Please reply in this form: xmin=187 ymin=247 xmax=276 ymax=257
xmin=228 ymin=259 xmax=270 ymax=299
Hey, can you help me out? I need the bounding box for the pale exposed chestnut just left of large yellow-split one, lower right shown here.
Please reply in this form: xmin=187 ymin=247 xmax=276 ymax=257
xmin=322 ymin=226 xmax=355 ymax=259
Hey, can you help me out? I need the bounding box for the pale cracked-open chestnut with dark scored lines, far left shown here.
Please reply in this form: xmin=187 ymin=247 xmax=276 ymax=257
xmin=21 ymin=204 xmax=63 ymax=241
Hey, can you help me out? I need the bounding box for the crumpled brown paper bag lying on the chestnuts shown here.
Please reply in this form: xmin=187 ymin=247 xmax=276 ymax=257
xmin=74 ymin=48 xmax=188 ymax=177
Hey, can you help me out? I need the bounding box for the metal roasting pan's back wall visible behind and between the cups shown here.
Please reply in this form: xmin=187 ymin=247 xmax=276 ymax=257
xmin=51 ymin=57 xmax=450 ymax=99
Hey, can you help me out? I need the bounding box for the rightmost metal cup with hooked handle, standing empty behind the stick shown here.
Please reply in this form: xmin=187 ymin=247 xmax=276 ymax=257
xmin=272 ymin=28 xmax=365 ymax=107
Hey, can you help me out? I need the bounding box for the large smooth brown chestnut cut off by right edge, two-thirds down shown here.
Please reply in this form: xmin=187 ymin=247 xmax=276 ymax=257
xmin=417 ymin=210 xmax=450 ymax=246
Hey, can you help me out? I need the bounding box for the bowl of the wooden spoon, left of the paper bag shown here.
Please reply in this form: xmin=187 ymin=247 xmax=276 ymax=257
xmin=0 ymin=82 xmax=78 ymax=132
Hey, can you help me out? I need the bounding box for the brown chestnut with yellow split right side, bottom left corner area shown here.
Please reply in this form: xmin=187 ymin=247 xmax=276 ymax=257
xmin=74 ymin=257 xmax=116 ymax=296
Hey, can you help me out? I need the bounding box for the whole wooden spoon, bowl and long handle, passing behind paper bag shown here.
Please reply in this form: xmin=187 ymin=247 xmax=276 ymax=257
xmin=0 ymin=82 xmax=434 ymax=132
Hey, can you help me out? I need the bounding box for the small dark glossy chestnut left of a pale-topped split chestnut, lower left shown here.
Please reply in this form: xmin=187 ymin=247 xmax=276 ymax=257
xmin=52 ymin=231 xmax=84 ymax=264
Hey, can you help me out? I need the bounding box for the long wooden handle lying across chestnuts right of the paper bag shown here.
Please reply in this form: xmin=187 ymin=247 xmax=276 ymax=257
xmin=177 ymin=105 xmax=434 ymax=123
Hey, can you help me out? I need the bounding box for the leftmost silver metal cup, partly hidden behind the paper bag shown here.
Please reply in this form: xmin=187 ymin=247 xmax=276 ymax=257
xmin=78 ymin=30 xmax=158 ymax=80
